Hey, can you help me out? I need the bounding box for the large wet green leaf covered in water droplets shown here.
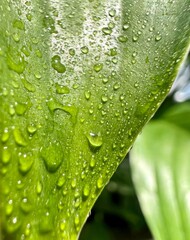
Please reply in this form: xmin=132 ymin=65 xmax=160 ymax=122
xmin=0 ymin=0 xmax=190 ymax=240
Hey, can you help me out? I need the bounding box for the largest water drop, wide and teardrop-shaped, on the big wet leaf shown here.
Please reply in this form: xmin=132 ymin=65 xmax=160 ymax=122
xmin=41 ymin=141 xmax=63 ymax=173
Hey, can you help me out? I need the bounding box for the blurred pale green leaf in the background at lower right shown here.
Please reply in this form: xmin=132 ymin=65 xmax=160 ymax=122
xmin=130 ymin=120 xmax=190 ymax=240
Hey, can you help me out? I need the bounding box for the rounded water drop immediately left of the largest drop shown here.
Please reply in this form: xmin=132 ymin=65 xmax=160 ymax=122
xmin=18 ymin=153 xmax=34 ymax=174
